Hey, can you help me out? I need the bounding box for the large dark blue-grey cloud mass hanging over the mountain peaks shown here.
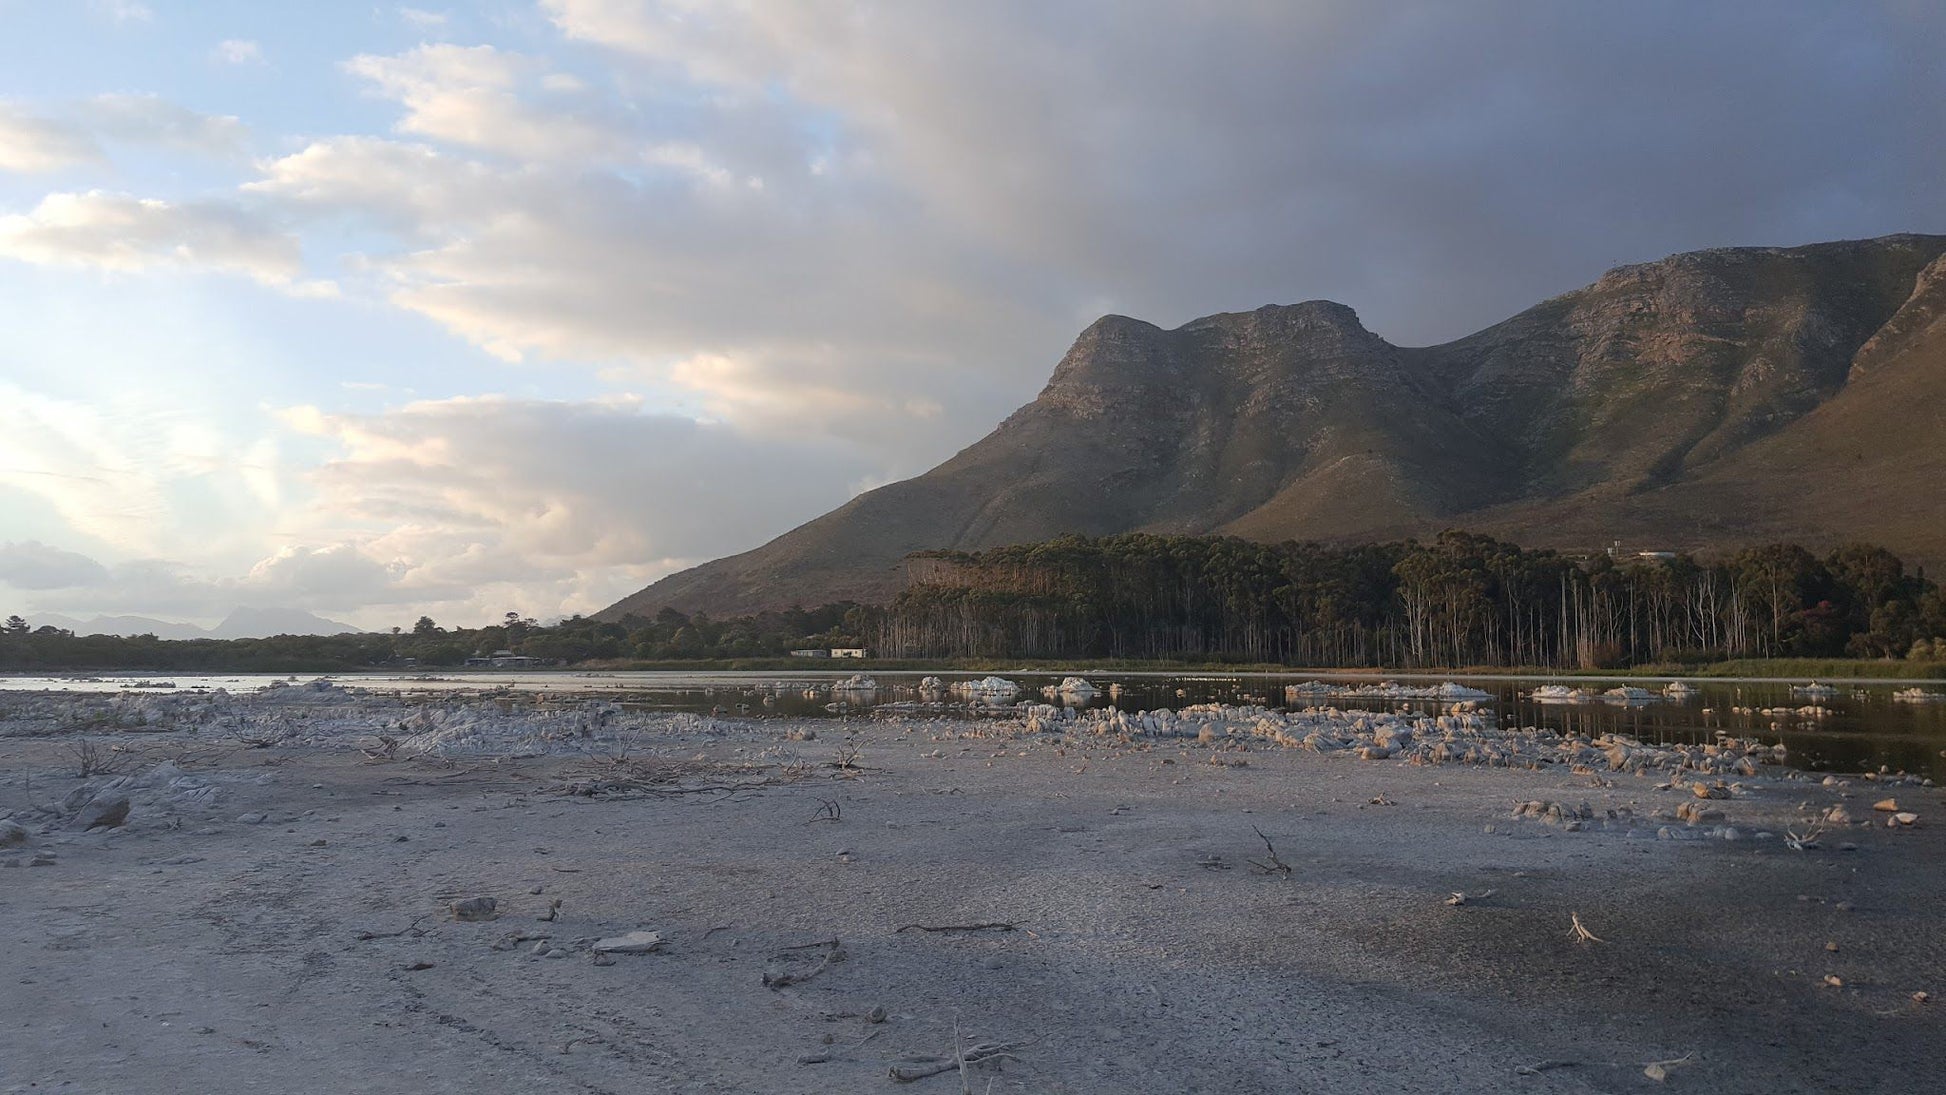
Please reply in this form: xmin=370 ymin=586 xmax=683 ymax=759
xmin=543 ymin=0 xmax=1946 ymax=340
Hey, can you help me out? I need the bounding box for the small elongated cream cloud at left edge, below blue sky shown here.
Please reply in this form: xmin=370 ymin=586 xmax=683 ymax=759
xmin=0 ymin=191 xmax=331 ymax=294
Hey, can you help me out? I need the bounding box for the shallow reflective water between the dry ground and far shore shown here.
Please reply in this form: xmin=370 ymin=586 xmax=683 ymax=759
xmin=0 ymin=671 xmax=1946 ymax=780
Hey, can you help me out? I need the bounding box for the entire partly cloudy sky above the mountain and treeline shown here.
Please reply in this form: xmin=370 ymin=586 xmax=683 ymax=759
xmin=0 ymin=0 xmax=1946 ymax=630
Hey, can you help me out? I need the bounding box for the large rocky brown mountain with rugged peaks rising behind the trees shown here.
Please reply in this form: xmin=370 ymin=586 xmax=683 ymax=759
xmin=599 ymin=235 xmax=1946 ymax=618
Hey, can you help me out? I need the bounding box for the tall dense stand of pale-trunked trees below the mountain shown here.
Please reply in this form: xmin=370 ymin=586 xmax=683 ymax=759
xmin=876 ymin=531 xmax=1946 ymax=669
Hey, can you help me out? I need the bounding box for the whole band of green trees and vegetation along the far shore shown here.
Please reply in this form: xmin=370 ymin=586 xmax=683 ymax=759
xmin=0 ymin=533 xmax=1946 ymax=677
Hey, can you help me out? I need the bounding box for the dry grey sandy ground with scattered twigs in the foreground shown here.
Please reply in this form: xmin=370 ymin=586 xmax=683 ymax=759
xmin=0 ymin=704 xmax=1946 ymax=1093
